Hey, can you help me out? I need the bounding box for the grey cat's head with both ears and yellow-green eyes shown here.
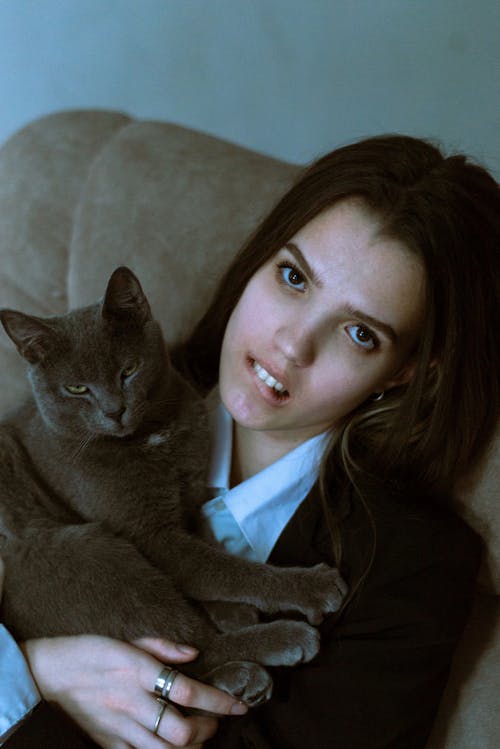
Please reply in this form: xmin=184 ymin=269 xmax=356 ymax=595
xmin=0 ymin=268 xmax=168 ymax=439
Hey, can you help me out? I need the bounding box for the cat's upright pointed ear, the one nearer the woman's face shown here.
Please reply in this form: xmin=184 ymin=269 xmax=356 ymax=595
xmin=102 ymin=266 xmax=151 ymax=325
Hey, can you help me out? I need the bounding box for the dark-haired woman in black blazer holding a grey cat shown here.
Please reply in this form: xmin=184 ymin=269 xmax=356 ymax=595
xmin=3 ymin=136 xmax=500 ymax=749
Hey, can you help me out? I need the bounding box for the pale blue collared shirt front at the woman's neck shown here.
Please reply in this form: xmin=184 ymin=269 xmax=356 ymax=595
xmin=201 ymin=404 xmax=330 ymax=562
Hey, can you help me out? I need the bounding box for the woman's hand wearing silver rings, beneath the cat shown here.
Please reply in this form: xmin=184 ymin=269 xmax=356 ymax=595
xmin=21 ymin=635 xmax=247 ymax=749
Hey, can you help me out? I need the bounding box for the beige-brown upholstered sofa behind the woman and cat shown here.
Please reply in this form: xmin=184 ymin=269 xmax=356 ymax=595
xmin=0 ymin=111 xmax=500 ymax=749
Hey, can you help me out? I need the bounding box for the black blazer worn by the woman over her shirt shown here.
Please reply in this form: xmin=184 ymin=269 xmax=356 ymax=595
xmin=5 ymin=480 xmax=480 ymax=749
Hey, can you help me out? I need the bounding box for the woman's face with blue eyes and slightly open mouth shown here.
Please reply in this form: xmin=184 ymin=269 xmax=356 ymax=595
xmin=219 ymin=200 xmax=424 ymax=443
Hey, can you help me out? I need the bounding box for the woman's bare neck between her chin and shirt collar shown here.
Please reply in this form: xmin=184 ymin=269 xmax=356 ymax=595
xmin=231 ymin=424 xmax=303 ymax=487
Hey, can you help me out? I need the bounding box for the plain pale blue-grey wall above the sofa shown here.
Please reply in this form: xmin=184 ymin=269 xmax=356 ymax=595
xmin=0 ymin=0 xmax=500 ymax=173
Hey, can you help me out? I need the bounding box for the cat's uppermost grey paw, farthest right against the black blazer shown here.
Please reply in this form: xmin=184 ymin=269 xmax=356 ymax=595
xmin=290 ymin=564 xmax=348 ymax=626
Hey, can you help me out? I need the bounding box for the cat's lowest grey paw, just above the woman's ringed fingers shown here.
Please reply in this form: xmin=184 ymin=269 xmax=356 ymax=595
xmin=203 ymin=661 xmax=273 ymax=707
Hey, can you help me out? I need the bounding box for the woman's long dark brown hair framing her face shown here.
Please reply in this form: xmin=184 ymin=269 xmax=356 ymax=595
xmin=175 ymin=135 xmax=500 ymax=560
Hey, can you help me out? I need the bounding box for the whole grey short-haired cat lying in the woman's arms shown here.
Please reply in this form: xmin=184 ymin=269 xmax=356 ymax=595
xmin=0 ymin=267 xmax=345 ymax=704
